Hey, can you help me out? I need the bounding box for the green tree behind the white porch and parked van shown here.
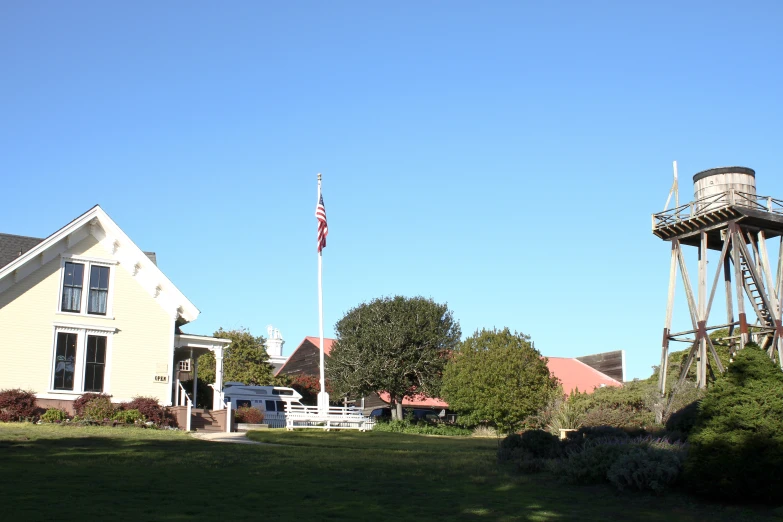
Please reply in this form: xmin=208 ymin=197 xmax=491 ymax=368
xmin=198 ymin=328 xmax=275 ymax=386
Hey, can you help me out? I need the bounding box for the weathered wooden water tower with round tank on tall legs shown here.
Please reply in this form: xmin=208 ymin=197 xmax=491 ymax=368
xmin=652 ymin=163 xmax=783 ymax=394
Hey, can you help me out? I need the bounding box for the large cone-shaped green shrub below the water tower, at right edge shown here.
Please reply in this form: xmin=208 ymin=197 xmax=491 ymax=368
xmin=684 ymin=343 xmax=783 ymax=504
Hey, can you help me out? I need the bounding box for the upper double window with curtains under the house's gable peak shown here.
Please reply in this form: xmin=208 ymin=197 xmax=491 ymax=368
xmin=59 ymin=258 xmax=112 ymax=316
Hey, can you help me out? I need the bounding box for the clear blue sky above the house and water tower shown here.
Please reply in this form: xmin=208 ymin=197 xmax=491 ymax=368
xmin=0 ymin=1 xmax=783 ymax=377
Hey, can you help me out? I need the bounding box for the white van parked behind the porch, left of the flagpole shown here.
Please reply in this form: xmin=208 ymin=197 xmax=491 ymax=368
xmin=223 ymin=382 xmax=302 ymax=428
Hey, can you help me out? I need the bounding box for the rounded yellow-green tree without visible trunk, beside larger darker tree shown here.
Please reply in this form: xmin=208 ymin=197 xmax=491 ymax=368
xmin=441 ymin=328 xmax=559 ymax=431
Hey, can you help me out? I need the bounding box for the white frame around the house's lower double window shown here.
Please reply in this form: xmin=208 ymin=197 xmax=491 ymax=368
xmin=47 ymin=323 xmax=117 ymax=399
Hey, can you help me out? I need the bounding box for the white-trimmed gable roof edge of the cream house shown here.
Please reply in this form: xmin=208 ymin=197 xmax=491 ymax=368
xmin=0 ymin=205 xmax=199 ymax=322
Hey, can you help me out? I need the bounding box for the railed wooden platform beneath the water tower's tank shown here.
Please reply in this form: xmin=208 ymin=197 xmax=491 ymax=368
xmin=652 ymin=190 xmax=783 ymax=250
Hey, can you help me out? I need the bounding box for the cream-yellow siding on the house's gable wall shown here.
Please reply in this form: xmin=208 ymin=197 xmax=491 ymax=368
xmin=0 ymin=235 xmax=174 ymax=404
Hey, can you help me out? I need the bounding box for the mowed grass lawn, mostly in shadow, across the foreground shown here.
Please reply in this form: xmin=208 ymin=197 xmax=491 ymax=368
xmin=0 ymin=424 xmax=780 ymax=521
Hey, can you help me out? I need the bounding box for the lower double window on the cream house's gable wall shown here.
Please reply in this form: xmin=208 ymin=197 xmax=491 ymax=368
xmin=51 ymin=326 xmax=113 ymax=393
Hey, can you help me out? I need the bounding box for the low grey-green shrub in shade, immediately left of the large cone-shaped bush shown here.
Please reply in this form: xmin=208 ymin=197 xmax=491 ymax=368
xmin=606 ymin=444 xmax=683 ymax=494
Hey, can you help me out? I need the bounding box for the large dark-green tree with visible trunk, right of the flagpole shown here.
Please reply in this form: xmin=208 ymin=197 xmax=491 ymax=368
xmin=326 ymin=296 xmax=461 ymax=419
